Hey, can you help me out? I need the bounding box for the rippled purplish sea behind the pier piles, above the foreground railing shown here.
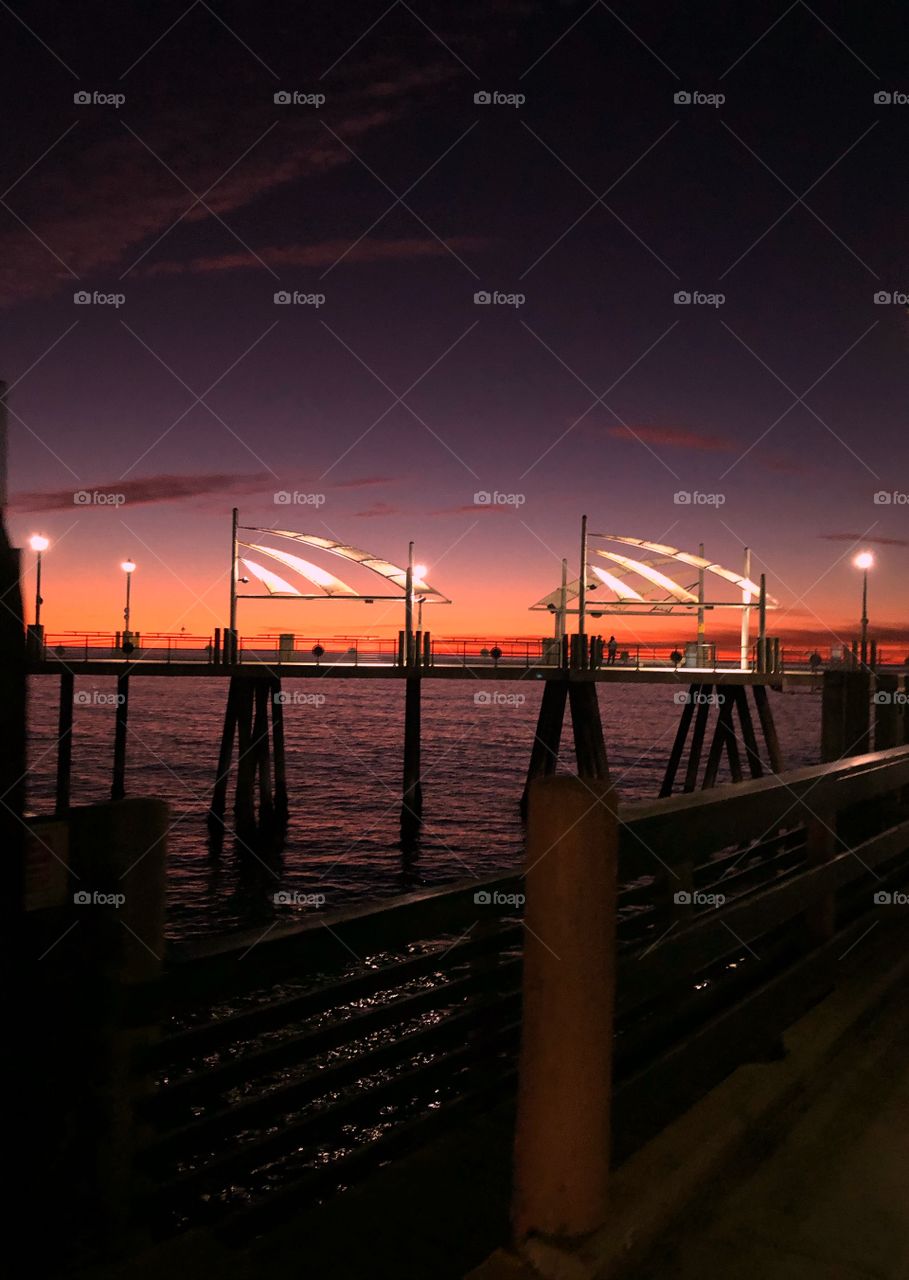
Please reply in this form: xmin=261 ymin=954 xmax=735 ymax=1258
xmin=28 ymin=676 xmax=821 ymax=940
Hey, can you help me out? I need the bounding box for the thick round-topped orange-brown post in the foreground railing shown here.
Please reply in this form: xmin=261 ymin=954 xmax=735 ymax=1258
xmin=512 ymin=777 xmax=618 ymax=1244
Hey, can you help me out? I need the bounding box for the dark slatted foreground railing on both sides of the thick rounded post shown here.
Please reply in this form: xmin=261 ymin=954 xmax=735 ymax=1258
xmin=115 ymin=748 xmax=909 ymax=1249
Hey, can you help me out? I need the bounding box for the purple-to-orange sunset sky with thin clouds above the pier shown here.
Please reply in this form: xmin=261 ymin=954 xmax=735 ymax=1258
xmin=0 ymin=0 xmax=909 ymax=643
